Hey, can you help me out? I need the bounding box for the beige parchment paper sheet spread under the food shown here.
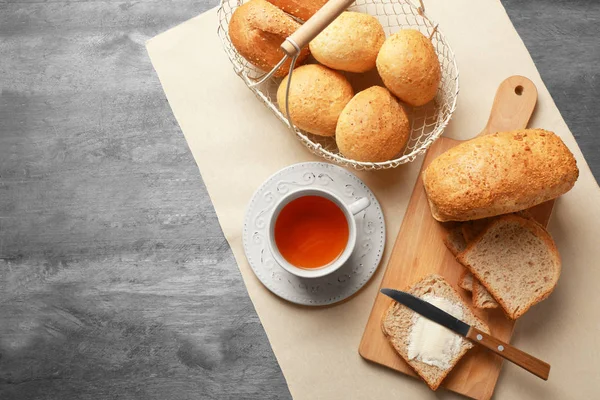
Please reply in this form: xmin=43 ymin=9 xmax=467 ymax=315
xmin=147 ymin=0 xmax=600 ymax=400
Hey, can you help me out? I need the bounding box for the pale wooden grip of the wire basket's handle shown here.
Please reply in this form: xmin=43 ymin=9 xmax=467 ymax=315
xmin=281 ymin=0 xmax=354 ymax=57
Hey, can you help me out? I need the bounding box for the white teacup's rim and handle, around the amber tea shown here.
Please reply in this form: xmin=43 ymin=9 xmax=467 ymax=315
xmin=268 ymin=188 xmax=371 ymax=278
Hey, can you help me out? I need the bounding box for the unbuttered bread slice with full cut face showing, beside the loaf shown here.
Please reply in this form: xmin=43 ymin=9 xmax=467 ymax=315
xmin=457 ymin=215 xmax=561 ymax=319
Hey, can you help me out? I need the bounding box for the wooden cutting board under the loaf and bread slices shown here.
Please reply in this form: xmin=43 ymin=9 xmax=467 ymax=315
xmin=359 ymin=76 xmax=554 ymax=399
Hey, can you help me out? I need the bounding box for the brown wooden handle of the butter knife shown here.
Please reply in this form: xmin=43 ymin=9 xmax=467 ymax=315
xmin=467 ymin=327 xmax=550 ymax=381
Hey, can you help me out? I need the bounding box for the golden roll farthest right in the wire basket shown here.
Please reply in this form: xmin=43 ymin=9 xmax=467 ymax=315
xmin=377 ymin=29 xmax=441 ymax=106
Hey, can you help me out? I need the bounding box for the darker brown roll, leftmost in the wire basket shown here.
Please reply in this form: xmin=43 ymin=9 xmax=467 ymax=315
xmin=229 ymin=0 xmax=308 ymax=77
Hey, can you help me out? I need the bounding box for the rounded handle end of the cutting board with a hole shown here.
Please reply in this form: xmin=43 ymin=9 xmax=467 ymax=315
xmin=479 ymin=75 xmax=537 ymax=135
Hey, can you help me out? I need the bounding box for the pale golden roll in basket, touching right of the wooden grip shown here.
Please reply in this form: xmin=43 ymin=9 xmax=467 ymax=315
xmin=309 ymin=11 xmax=385 ymax=72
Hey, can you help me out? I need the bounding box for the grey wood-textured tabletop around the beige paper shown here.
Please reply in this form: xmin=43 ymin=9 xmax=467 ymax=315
xmin=0 ymin=0 xmax=600 ymax=400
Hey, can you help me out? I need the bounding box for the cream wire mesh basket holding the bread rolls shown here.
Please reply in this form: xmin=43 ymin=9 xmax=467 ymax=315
xmin=217 ymin=0 xmax=458 ymax=170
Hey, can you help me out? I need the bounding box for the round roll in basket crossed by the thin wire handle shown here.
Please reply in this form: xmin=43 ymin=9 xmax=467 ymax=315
xmin=277 ymin=64 xmax=354 ymax=136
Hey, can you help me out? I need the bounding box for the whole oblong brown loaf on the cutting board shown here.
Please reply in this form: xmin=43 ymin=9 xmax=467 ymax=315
xmin=422 ymin=129 xmax=579 ymax=221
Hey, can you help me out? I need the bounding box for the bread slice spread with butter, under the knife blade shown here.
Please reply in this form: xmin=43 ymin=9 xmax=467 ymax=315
xmin=381 ymin=275 xmax=490 ymax=390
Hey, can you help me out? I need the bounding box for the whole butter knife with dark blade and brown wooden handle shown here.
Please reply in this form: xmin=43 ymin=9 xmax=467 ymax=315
xmin=380 ymin=288 xmax=550 ymax=380
